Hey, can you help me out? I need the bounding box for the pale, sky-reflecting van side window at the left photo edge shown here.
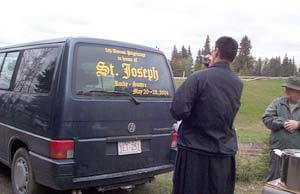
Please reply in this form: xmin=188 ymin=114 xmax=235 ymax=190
xmin=0 ymin=52 xmax=19 ymax=89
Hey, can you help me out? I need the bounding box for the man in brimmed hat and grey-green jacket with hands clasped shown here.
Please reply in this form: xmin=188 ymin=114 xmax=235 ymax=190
xmin=262 ymin=77 xmax=300 ymax=181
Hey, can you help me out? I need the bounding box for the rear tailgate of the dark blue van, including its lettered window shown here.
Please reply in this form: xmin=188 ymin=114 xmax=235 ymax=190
xmin=64 ymin=44 xmax=175 ymax=176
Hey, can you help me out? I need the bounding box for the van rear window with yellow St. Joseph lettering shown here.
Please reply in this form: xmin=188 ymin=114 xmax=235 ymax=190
xmin=72 ymin=44 xmax=173 ymax=97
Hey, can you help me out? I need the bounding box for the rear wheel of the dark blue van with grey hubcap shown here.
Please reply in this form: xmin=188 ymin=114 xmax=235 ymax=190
xmin=11 ymin=148 xmax=39 ymax=194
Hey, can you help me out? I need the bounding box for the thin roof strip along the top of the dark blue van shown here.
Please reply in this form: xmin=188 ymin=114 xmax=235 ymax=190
xmin=0 ymin=37 xmax=162 ymax=53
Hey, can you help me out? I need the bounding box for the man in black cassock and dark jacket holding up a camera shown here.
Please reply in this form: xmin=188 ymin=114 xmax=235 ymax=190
xmin=171 ymin=36 xmax=243 ymax=194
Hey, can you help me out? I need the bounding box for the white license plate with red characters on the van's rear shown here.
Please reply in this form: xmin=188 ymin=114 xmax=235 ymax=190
xmin=118 ymin=141 xmax=142 ymax=155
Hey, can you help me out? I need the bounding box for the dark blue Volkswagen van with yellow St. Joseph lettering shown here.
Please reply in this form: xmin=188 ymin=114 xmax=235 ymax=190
xmin=0 ymin=38 xmax=176 ymax=194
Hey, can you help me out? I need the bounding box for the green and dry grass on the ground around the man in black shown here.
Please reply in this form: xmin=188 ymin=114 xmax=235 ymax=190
xmin=132 ymin=79 xmax=284 ymax=194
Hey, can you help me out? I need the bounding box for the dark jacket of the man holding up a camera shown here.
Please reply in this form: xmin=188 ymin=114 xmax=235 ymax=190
xmin=171 ymin=62 xmax=243 ymax=155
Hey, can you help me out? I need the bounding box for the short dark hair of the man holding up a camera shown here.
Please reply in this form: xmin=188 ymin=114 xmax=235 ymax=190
xmin=216 ymin=36 xmax=238 ymax=62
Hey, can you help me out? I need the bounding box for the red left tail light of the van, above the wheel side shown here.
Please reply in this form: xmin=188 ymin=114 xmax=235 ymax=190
xmin=50 ymin=140 xmax=74 ymax=159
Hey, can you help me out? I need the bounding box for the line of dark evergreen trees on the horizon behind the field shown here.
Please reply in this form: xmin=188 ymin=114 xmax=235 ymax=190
xmin=170 ymin=35 xmax=298 ymax=77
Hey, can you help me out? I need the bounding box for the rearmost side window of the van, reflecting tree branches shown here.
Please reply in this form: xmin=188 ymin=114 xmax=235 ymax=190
xmin=14 ymin=47 xmax=59 ymax=93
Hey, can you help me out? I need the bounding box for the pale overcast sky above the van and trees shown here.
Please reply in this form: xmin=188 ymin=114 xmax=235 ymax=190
xmin=0 ymin=0 xmax=300 ymax=64
